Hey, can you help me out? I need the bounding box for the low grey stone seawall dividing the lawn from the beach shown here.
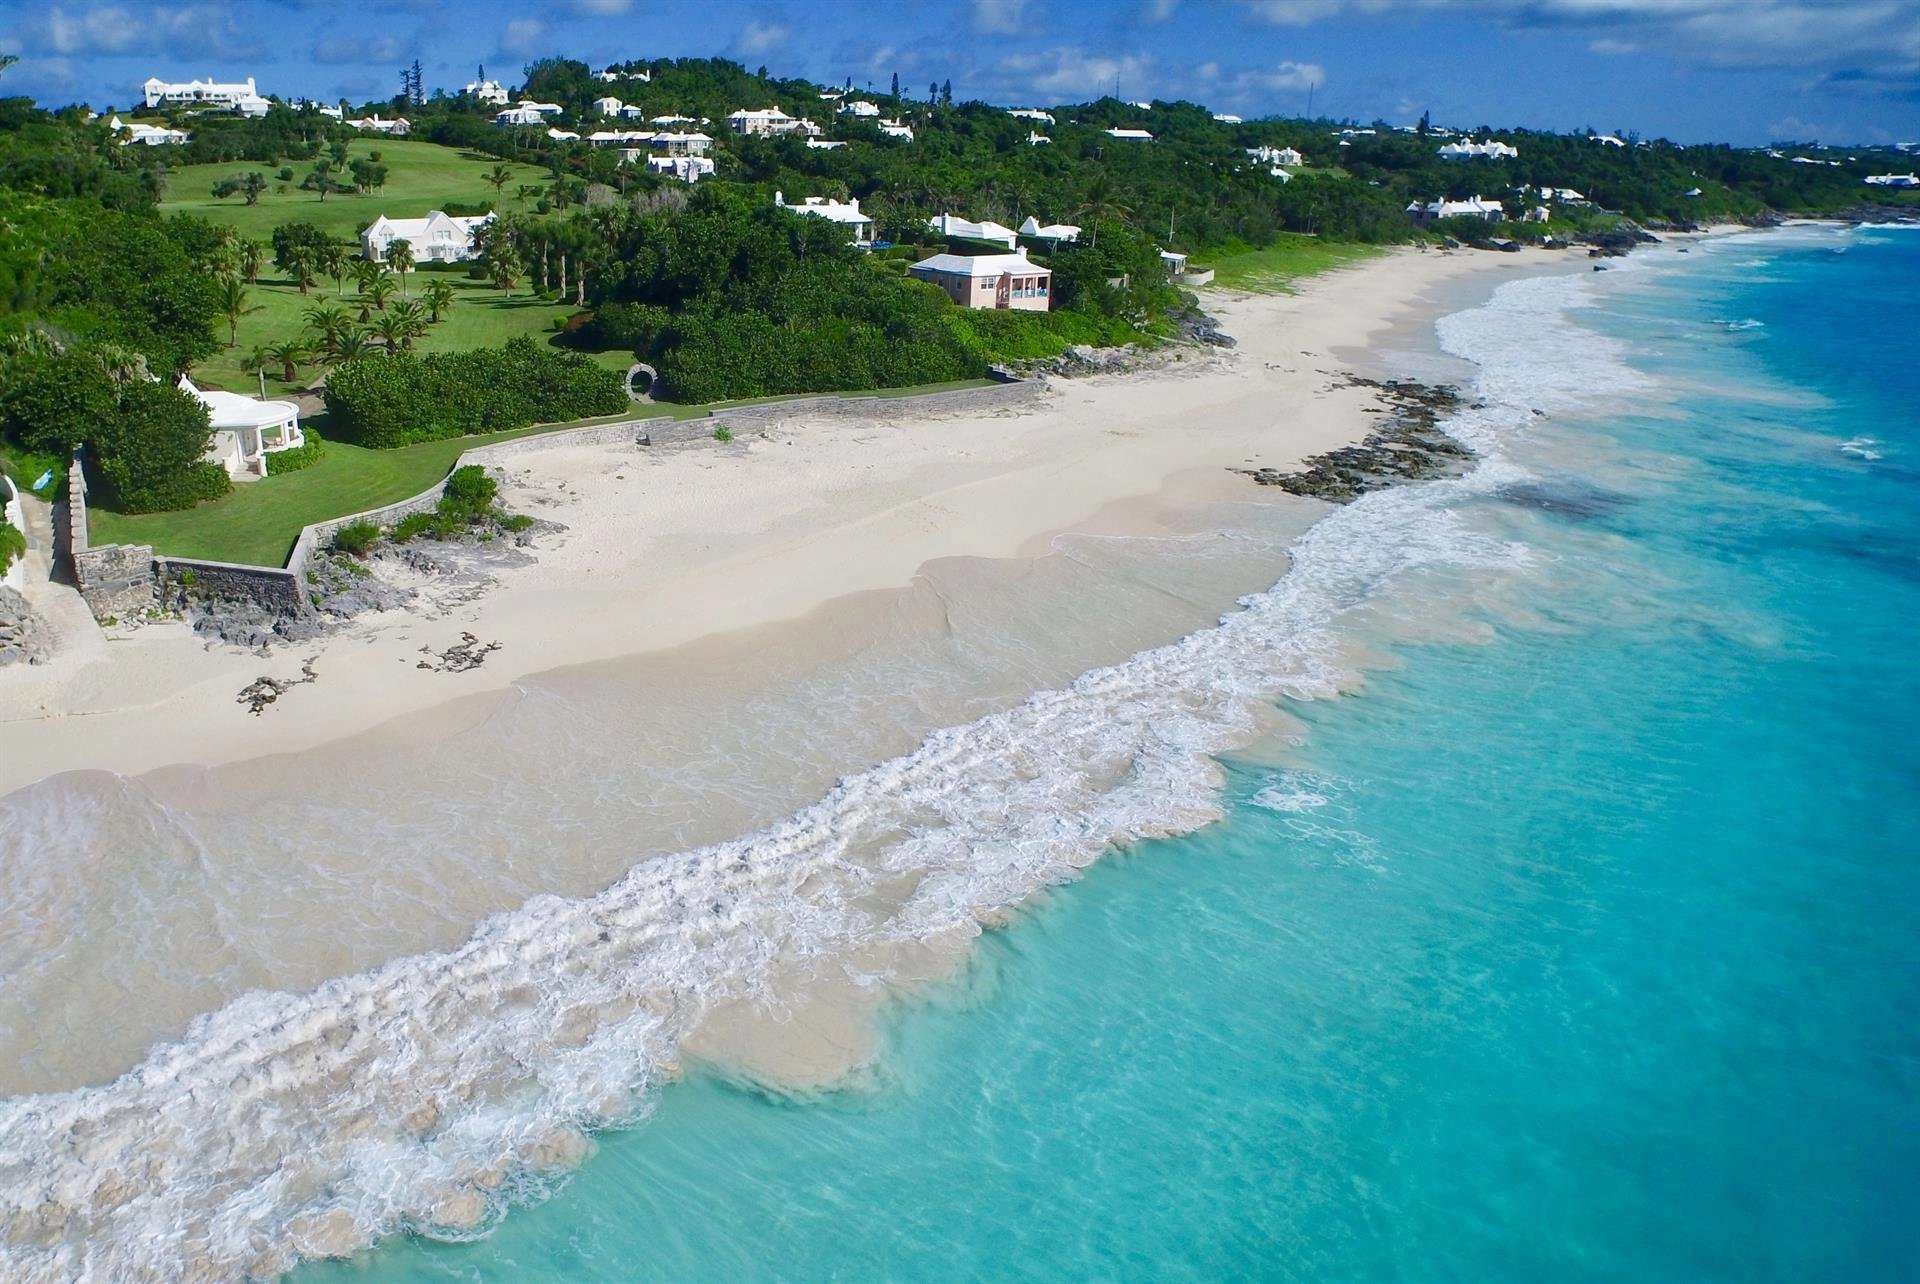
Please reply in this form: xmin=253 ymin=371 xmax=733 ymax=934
xmin=69 ymin=380 xmax=1044 ymax=618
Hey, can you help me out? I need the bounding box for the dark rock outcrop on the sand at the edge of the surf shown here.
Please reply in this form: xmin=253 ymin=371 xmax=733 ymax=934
xmin=1235 ymin=376 xmax=1473 ymax=503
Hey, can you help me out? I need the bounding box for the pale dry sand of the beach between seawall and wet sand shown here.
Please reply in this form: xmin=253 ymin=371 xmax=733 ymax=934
xmin=0 ymin=251 xmax=1572 ymax=795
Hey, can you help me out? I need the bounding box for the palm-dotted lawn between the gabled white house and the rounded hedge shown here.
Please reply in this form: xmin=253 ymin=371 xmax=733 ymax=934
xmin=194 ymin=269 xmax=602 ymax=397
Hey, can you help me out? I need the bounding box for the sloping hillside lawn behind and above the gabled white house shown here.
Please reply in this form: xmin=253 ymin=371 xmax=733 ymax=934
xmin=161 ymin=138 xmax=547 ymax=240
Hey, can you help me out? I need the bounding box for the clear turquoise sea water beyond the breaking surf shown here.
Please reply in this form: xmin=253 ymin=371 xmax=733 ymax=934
xmin=301 ymin=230 xmax=1920 ymax=1282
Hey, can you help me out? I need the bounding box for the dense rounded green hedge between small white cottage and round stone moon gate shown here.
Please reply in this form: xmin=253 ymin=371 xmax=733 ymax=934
xmin=326 ymin=336 xmax=628 ymax=447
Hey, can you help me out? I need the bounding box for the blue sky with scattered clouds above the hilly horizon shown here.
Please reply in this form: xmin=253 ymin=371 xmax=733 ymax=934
xmin=0 ymin=0 xmax=1920 ymax=144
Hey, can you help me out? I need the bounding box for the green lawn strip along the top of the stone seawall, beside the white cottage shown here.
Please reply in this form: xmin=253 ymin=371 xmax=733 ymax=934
xmin=86 ymin=407 xmax=637 ymax=566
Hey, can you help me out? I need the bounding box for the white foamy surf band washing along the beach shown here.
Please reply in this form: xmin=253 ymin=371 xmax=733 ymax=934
xmin=0 ymin=268 xmax=1636 ymax=1280
